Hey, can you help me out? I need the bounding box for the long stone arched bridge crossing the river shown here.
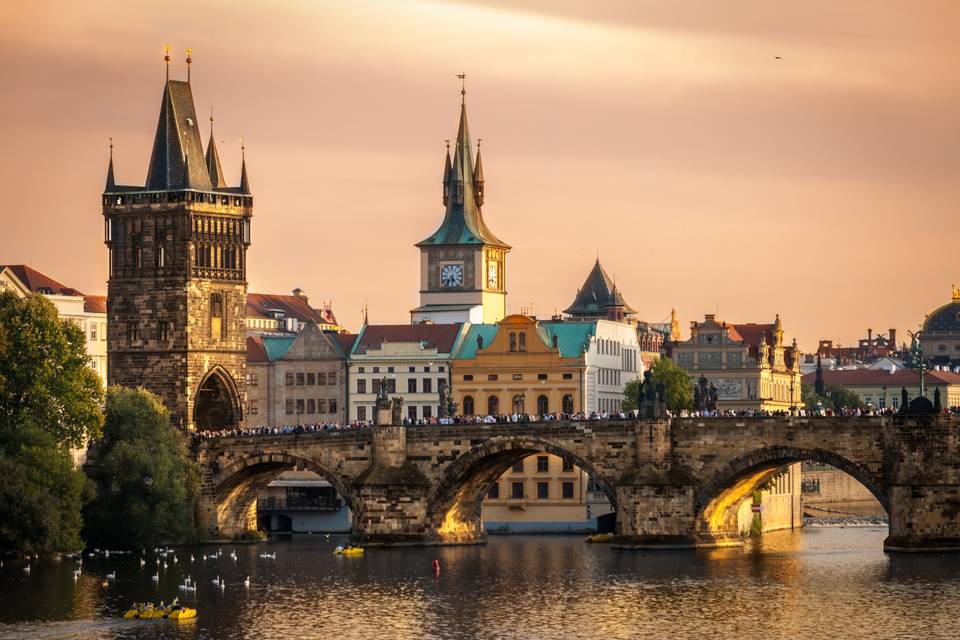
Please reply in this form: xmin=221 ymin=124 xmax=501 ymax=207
xmin=197 ymin=416 xmax=960 ymax=551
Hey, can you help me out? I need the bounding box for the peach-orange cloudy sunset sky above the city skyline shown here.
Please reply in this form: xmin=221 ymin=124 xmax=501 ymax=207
xmin=0 ymin=0 xmax=960 ymax=351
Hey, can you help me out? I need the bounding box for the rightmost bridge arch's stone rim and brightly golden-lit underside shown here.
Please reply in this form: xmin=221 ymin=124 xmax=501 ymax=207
xmin=694 ymin=446 xmax=890 ymax=543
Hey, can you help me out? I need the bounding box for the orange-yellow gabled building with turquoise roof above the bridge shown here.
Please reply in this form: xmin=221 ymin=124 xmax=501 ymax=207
xmin=451 ymin=315 xmax=595 ymax=416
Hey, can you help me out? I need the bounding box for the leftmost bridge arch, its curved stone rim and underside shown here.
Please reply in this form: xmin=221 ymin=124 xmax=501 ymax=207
xmin=214 ymin=451 xmax=357 ymax=536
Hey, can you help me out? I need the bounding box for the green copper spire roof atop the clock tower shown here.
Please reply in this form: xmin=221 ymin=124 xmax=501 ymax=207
xmin=417 ymin=99 xmax=510 ymax=249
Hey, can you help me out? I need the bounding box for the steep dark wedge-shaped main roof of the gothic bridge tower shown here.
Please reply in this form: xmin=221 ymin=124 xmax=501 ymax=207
xmin=146 ymin=80 xmax=211 ymax=191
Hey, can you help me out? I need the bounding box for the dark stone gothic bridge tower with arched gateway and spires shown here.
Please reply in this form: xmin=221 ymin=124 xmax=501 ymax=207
xmin=103 ymin=53 xmax=253 ymax=430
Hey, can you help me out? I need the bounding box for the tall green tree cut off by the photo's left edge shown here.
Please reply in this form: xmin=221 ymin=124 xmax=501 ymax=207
xmin=0 ymin=292 xmax=103 ymax=553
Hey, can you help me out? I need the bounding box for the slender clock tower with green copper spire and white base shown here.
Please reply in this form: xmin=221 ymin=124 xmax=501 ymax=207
xmin=410 ymin=85 xmax=510 ymax=324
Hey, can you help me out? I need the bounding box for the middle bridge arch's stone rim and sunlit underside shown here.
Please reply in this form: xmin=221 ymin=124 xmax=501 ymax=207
xmin=427 ymin=436 xmax=617 ymax=543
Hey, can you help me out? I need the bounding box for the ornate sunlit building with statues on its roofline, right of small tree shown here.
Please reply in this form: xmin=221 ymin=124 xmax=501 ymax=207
xmin=671 ymin=313 xmax=802 ymax=411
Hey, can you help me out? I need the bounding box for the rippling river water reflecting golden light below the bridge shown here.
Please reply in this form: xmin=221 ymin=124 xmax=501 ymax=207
xmin=0 ymin=527 xmax=960 ymax=640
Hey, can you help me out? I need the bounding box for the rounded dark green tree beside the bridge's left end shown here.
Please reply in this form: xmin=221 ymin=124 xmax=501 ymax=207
xmin=84 ymin=387 xmax=199 ymax=549
